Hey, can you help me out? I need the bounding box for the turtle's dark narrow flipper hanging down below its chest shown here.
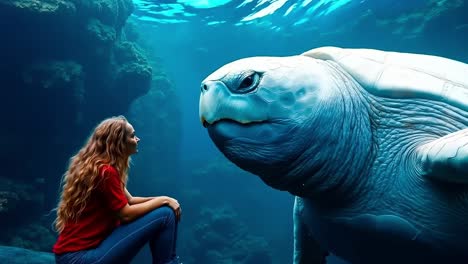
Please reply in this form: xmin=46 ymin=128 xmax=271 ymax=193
xmin=293 ymin=196 xmax=329 ymax=264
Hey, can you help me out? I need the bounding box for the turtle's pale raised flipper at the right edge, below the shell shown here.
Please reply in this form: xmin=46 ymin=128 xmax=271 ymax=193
xmin=419 ymin=128 xmax=468 ymax=184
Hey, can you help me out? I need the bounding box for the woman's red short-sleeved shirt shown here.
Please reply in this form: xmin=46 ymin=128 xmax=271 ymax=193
xmin=52 ymin=165 xmax=128 ymax=254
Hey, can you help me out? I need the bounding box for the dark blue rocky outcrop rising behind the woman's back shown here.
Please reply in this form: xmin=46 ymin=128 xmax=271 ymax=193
xmin=0 ymin=0 xmax=153 ymax=252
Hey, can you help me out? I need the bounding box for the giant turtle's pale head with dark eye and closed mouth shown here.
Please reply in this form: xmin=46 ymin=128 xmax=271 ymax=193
xmin=199 ymin=56 xmax=354 ymax=195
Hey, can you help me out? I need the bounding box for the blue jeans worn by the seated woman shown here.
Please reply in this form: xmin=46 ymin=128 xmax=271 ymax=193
xmin=55 ymin=206 xmax=179 ymax=264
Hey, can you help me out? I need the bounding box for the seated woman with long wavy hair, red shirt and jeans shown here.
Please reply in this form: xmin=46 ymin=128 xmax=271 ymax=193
xmin=53 ymin=116 xmax=181 ymax=264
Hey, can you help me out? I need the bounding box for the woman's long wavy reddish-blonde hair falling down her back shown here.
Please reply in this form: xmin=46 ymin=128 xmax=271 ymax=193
xmin=54 ymin=116 xmax=131 ymax=233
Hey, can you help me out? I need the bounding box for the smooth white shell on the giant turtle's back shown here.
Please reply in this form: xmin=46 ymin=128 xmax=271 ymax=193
xmin=301 ymin=47 xmax=468 ymax=111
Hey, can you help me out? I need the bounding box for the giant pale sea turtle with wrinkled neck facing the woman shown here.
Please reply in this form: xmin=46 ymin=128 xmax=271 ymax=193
xmin=199 ymin=47 xmax=468 ymax=264
